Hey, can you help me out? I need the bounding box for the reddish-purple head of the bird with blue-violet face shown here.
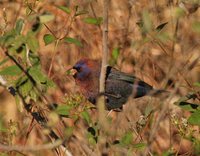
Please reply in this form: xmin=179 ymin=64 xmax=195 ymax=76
xmin=73 ymin=58 xmax=99 ymax=80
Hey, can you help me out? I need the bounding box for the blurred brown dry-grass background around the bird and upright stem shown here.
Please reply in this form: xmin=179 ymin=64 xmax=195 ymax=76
xmin=0 ymin=0 xmax=200 ymax=155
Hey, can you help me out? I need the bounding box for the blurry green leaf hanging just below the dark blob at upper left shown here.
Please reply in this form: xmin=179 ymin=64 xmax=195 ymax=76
xmin=26 ymin=31 xmax=39 ymax=52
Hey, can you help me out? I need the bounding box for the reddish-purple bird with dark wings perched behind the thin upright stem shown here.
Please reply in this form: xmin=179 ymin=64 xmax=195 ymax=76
xmin=72 ymin=58 xmax=165 ymax=110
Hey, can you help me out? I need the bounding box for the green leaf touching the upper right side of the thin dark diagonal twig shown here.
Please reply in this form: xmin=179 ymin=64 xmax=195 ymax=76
xmin=28 ymin=66 xmax=47 ymax=84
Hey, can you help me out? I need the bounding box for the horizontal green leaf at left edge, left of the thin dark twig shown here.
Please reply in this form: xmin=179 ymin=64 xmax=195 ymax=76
xmin=0 ymin=65 xmax=22 ymax=76
